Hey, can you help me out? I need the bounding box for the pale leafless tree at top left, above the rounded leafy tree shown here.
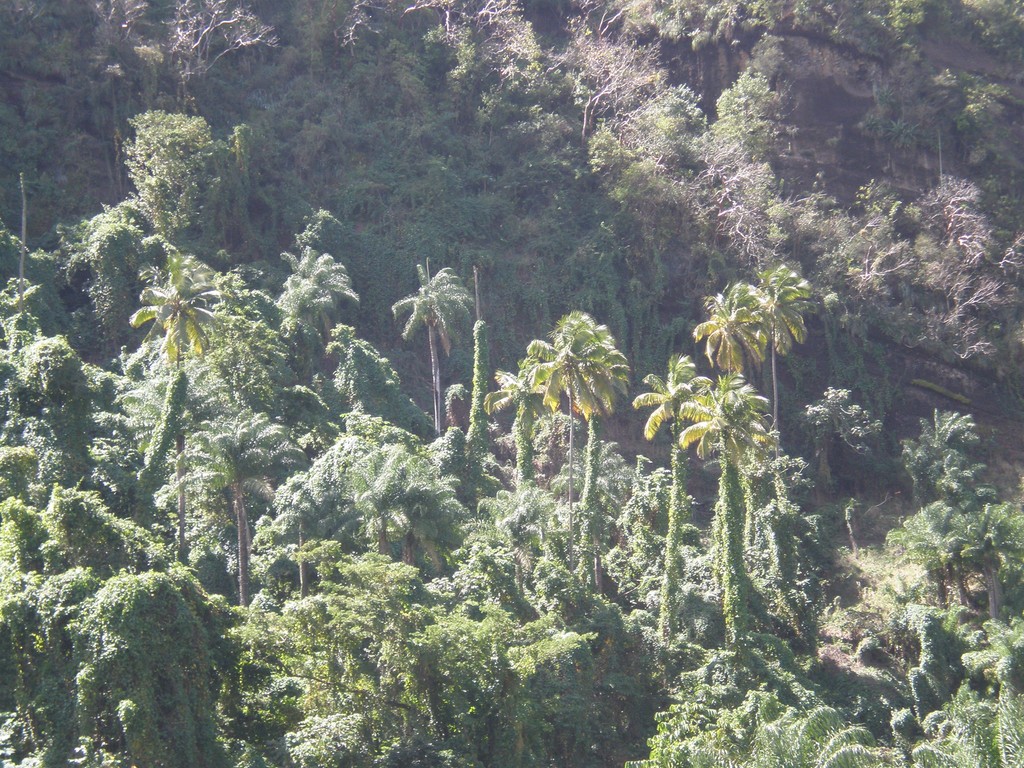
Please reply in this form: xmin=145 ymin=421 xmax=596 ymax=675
xmin=170 ymin=0 xmax=278 ymax=82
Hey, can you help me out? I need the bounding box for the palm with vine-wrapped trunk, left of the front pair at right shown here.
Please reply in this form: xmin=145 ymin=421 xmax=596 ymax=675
xmin=633 ymin=354 xmax=711 ymax=642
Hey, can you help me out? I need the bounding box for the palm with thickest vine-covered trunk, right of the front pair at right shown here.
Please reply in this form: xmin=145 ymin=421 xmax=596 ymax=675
xmin=679 ymin=374 xmax=773 ymax=642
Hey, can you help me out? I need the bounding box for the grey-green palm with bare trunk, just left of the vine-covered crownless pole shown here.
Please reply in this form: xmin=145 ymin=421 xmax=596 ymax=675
xmin=391 ymin=264 xmax=473 ymax=436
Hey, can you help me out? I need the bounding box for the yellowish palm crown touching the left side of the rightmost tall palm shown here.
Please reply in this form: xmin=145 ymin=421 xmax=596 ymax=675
xmin=693 ymin=283 xmax=767 ymax=373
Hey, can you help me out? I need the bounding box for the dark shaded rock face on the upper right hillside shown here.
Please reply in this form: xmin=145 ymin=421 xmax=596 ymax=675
xmin=663 ymin=29 xmax=1024 ymax=204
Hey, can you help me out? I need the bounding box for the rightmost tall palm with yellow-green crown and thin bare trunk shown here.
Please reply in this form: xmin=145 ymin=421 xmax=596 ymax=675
xmin=757 ymin=264 xmax=812 ymax=438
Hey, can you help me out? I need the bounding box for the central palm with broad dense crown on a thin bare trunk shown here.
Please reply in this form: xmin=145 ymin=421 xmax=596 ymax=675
xmin=525 ymin=311 xmax=630 ymax=567
